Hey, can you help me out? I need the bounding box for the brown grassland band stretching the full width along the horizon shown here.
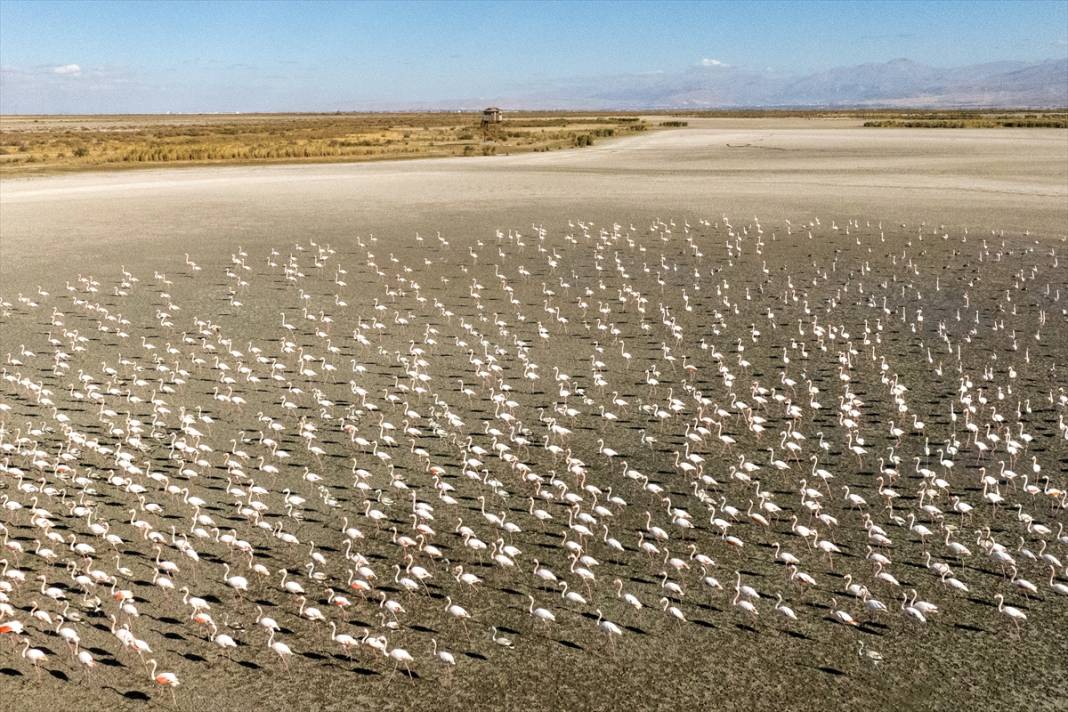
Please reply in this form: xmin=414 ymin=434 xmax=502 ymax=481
xmin=0 ymin=110 xmax=1068 ymax=176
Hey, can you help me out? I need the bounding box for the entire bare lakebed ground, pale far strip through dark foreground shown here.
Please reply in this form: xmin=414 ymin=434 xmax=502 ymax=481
xmin=0 ymin=120 xmax=1068 ymax=710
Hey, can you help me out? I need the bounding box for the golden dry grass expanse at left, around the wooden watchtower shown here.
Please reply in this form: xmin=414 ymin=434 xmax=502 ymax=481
xmin=0 ymin=113 xmax=647 ymax=175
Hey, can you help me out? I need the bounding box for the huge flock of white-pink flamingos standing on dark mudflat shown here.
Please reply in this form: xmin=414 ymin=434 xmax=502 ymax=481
xmin=0 ymin=218 xmax=1068 ymax=705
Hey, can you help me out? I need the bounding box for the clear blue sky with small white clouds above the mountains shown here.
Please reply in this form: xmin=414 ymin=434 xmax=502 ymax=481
xmin=0 ymin=0 xmax=1068 ymax=113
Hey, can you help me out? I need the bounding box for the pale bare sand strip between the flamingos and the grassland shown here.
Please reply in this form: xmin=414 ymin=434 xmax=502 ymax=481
xmin=6 ymin=120 xmax=1068 ymax=294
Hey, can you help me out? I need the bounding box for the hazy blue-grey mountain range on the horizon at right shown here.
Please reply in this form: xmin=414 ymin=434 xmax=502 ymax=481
xmin=453 ymin=59 xmax=1068 ymax=109
